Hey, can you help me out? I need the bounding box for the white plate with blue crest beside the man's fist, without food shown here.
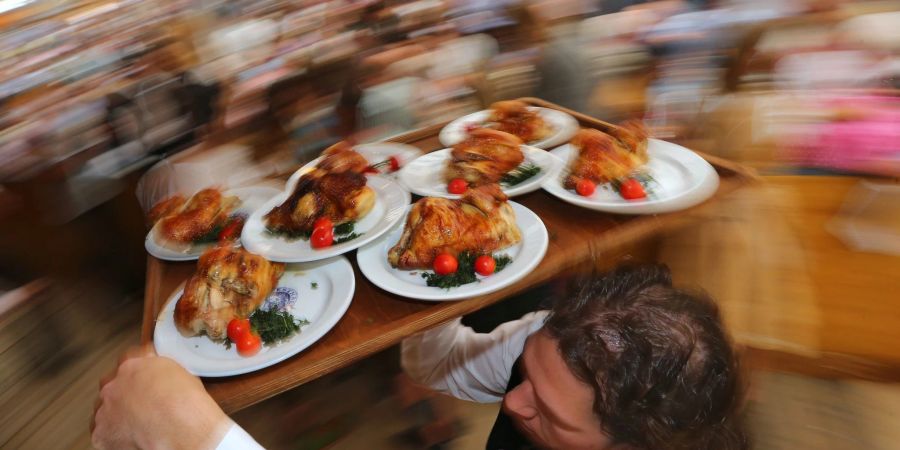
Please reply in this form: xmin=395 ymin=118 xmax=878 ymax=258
xmin=153 ymin=256 xmax=355 ymax=377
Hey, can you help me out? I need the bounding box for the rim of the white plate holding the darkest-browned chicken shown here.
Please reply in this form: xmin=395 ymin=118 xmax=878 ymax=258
xmin=241 ymin=175 xmax=412 ymax=263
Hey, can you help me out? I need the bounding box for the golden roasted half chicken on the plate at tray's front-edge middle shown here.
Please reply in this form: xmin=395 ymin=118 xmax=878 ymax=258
xmin=388 ymin=184 xmax=522 ymax=269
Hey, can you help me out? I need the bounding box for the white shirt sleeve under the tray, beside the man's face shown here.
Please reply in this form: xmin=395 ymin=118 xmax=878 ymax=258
xmin=401 ymin=311 xmax=548 ymax=403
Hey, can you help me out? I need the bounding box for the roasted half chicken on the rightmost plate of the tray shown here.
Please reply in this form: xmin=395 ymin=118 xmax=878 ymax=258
xmin=564 ymin=121 xmax=648 ymax=189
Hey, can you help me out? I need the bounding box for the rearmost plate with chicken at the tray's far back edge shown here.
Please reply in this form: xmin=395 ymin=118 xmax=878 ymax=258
xmin=438 ymin=100 xmax=578 ymax=149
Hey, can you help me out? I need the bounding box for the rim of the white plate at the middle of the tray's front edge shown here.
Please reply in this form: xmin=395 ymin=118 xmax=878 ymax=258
xmin=356 ymin=201 xmax=550 ymax=302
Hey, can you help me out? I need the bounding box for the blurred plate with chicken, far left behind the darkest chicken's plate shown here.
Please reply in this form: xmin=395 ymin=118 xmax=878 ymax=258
xmin=144 ymin=186 xmax=278 ymax=261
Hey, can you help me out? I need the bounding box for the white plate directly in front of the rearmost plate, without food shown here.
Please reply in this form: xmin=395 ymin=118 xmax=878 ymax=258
xmin=400 ymin=145 xmax=563 ymax=198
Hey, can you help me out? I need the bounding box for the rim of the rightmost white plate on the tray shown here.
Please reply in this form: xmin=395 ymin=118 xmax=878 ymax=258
xmin=541 ymin=138 xmax=720 ymax=215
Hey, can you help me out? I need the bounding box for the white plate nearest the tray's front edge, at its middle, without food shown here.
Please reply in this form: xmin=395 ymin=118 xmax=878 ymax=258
xmin=356 ymin=202 xmax=550 ymax=301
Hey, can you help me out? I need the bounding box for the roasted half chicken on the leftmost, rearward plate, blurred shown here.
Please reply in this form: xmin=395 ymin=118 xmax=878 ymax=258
xmin=150 ymin=188 xmax=240 ymax=244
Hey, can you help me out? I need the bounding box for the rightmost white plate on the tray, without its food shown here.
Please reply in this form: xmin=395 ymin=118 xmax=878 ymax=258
xmin=544 ymin=139 xmax=719 ymax=214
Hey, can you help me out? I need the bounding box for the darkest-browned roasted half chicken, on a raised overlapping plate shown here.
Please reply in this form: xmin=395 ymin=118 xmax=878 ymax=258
xmin=264 ymin=142 xmax=375 ymax=235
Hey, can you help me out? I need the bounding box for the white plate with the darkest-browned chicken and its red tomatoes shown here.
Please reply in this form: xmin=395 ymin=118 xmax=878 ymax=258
xmin=241 ymin=143 xmax=410 ymax=262
